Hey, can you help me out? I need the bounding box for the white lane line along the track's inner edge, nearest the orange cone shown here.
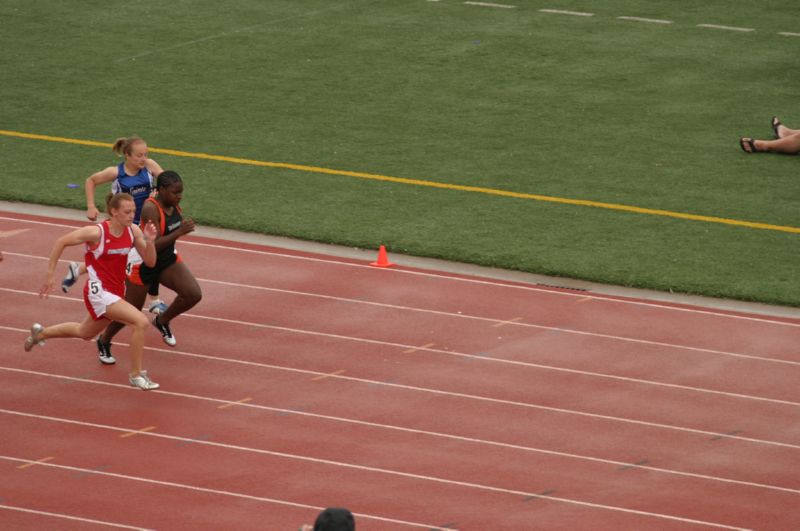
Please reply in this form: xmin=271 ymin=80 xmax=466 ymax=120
xmin=0 ymin=216 xmax=800 ymax=328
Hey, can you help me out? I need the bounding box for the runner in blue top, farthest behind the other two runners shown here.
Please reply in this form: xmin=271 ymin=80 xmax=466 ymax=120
xmin=61 ymin=136 xmax=167 ymax=313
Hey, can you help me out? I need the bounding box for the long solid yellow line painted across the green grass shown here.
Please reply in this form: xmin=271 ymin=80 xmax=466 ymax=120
xmin=0 ymin=129 xmax=800 ymax=234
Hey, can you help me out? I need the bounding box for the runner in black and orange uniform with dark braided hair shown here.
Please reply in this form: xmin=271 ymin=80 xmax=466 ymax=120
xmin=97 ymin=171 xmax=203 ymax=364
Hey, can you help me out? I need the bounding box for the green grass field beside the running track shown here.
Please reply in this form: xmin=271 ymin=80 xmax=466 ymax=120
xmin=0 ymin=0 xmax=800 ymax=306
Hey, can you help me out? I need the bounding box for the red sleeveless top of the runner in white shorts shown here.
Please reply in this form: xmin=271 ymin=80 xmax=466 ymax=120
xmin=84 ymin=220 xmax=133 ymax=297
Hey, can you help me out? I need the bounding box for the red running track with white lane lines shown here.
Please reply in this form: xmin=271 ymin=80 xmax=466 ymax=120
xmin=0 ymin=212 xmax=800 ymax=530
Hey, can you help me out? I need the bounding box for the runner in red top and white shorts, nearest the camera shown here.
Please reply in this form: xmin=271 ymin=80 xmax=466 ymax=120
xmin=25 ymin=194 xmax=158 ymax=390
